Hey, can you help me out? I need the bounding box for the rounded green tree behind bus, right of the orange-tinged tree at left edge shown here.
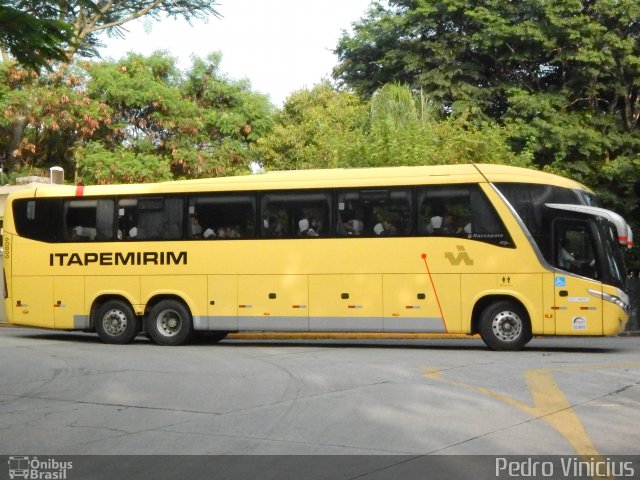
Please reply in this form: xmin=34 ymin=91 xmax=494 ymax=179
xmin=73 ymin=52 xmax=272 ymax=183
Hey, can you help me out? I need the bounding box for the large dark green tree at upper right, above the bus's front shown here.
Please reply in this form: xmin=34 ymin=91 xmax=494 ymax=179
xmin=334 ymin=0 xmax=640 ymax=251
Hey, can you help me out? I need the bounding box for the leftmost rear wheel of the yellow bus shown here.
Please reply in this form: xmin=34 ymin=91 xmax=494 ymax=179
xmin=94 ymin=300 xmax=140 ymax=345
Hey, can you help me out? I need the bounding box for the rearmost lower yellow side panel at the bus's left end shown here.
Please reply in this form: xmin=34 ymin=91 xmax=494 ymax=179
xmin=11 ymin=275 xmax=54 ymax=328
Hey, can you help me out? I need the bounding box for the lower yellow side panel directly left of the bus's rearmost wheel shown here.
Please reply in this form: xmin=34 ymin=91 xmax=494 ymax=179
xmin=53 ymin=276 xmax=89 ymax=330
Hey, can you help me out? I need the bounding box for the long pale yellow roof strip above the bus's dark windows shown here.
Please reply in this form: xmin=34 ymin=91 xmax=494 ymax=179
xmin=7 ymin=164 xmax=589 ymax=198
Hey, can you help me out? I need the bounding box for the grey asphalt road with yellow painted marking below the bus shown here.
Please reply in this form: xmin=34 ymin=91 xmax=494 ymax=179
xmin=0 ymin=327 xmax=640 ymax=460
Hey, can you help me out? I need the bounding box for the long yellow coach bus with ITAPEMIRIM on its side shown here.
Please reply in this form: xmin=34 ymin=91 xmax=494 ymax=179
xmin=3 ymin=165 xmax=631 ymax=350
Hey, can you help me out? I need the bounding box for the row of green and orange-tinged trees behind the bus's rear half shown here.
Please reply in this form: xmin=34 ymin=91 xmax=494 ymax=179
xmin=0 ymin=52 xmax=272 ymax=183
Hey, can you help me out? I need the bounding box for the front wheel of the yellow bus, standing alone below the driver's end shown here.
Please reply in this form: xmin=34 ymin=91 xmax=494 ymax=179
xmin=479 ymin=300 xmax=532 ymax=350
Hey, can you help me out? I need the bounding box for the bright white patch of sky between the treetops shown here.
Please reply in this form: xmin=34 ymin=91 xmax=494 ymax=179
xmin=100 ymin=0 xmax=371 ymax=106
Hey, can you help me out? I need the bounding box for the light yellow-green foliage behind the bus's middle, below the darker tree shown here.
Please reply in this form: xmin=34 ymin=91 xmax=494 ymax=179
xmin=255 ymin=84 xmax=531 ymax=169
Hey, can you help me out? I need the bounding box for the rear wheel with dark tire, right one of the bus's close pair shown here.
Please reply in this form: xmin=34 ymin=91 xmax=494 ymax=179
xmin=146 ymin=299 xmax=193 ymax=346
